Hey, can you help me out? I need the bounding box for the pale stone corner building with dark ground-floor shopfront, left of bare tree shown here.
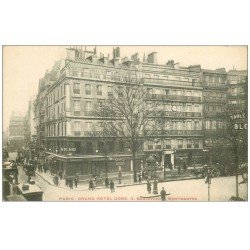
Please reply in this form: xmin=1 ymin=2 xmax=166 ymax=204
xmin=46 ymin=48 xmax=142 ymax=179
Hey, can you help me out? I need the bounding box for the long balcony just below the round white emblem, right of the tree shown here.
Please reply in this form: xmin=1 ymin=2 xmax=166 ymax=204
xmin=147 ymin=111 xmax=202 ymax=118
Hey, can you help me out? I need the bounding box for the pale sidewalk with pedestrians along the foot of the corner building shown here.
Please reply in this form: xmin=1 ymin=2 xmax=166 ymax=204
xmin=36 ymin=171 xmax=196 ymax=191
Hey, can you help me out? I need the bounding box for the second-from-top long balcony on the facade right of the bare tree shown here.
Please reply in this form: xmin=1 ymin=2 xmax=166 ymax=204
xmin=146 ymin=94 xmax=201 ymax=102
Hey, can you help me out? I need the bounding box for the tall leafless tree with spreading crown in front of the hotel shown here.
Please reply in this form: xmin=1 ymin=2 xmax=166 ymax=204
xmin=94 ymin=80 xmax=158 ymax=182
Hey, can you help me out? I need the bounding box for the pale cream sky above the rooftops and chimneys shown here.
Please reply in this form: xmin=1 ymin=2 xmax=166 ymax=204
xmin=3 ymin=45 xmax=247 ymax=131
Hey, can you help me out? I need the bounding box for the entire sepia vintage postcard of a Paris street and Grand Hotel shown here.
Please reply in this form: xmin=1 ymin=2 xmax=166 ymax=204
xmin=2 ymin=45 xmax=248 ymax=202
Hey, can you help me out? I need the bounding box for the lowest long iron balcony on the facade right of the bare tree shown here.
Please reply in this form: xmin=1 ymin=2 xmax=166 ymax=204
xmin=146 ymin=130 xmax=203 ymax=136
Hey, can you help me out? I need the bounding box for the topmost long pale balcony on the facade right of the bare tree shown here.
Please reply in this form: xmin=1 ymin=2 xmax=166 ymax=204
xmin=142 ymin=78 xmax=202 ymax=87
